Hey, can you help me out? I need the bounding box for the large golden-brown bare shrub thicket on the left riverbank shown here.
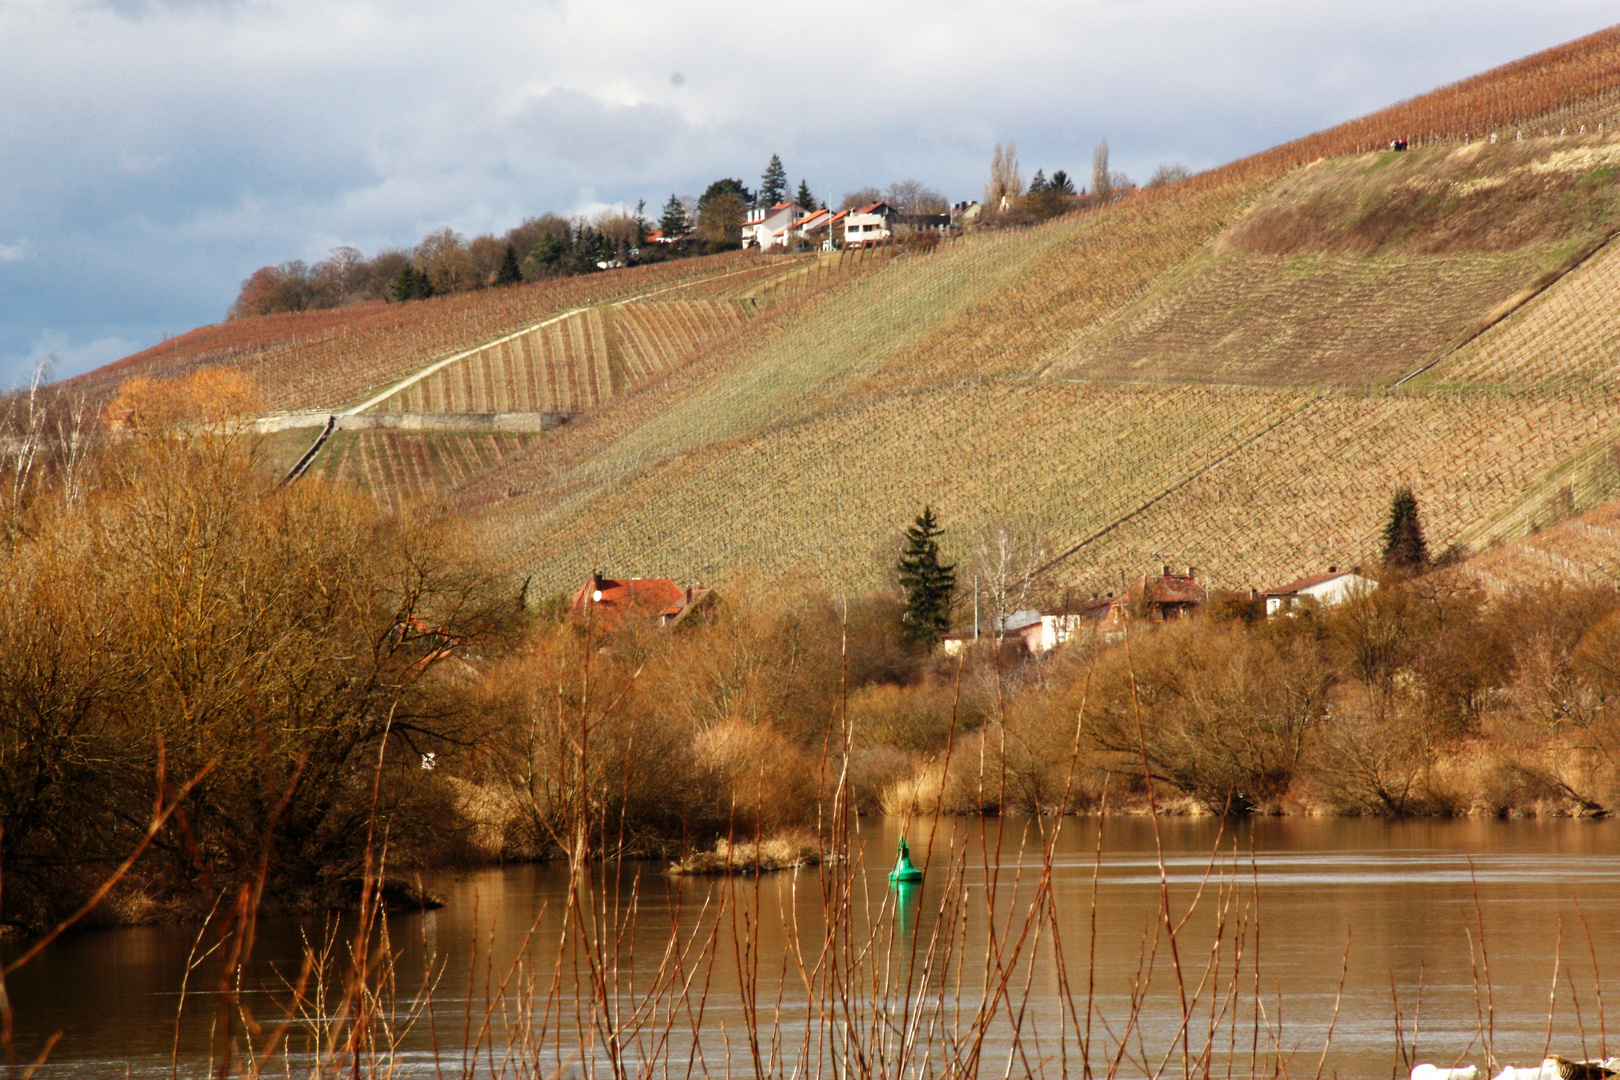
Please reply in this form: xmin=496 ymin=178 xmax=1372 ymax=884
xmin=0 ymin=374 xmax=510 ymax=925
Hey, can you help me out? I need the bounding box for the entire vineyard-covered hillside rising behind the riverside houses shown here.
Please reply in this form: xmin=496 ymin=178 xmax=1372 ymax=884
xmin=84 ymin=31 xmax=1620 ymax=591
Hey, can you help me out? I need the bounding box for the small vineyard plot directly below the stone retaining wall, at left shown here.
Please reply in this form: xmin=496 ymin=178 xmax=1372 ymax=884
xmin=311 ymin=431 xmax=541 ymax=512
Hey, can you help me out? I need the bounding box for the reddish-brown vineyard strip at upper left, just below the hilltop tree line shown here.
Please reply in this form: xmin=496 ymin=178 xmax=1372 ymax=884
xmin=73 ymin=253 xmax=781 ymax=413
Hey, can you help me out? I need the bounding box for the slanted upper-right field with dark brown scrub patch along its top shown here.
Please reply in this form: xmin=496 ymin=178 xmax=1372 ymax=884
xmin=1051 ymin=134 xmax=1620 ymax=385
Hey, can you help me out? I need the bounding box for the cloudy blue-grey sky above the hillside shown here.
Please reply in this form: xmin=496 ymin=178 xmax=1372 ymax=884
xmin=0 ymin=0 xmax=1620 ymax=385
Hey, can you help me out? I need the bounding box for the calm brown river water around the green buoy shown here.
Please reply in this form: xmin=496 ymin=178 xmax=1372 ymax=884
xmin=0 ymin=818 xmax=1620 ymax=1077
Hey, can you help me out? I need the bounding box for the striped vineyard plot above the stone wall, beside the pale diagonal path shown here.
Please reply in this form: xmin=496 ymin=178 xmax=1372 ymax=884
xmin=368 ymin=300 xmax=752 ymax=413
